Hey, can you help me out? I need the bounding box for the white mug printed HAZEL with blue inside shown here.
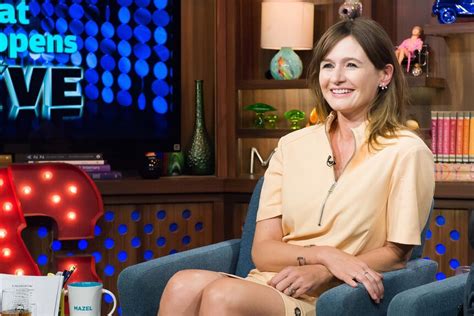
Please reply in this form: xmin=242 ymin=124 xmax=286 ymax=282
xmin=64 ymin=282 xmax=117 ymax=316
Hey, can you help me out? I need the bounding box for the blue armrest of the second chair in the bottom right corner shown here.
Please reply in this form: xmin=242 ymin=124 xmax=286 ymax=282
xmin=388 ymin=273 xmax=468 ymax=316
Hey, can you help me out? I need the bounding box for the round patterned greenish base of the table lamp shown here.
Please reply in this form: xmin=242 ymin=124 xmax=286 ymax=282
xmin=270 ymin=47 xmax=303 ymax=80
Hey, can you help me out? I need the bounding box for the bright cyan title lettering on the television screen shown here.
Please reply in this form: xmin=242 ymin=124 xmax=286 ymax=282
xmin=0 ymin=0 xmax=84 ymax=120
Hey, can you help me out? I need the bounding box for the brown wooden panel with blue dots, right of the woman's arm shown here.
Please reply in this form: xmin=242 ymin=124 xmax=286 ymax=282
xmin=423 ymin=209 xmax=471 ymax=277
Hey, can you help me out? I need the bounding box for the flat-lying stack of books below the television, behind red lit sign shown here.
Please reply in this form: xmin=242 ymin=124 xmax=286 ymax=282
xmin=15 ymin=153 xmax=122 ymax=180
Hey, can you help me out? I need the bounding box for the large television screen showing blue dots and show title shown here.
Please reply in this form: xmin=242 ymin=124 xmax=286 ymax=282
xmin=0 ymin=0 xmax=180 ymax=169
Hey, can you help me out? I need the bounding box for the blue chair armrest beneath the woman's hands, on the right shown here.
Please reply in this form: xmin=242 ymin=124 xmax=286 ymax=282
xmin=316 ymin=259 xmax=438 ymax=316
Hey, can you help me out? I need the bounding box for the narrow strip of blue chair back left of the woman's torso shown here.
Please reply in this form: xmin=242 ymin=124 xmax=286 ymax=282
xmin=235 ymin=177 xmax=263 ymax=277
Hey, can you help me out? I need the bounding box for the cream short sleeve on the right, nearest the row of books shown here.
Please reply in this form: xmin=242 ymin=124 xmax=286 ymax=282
xmin=387 ymin=145 xmax=435 ymax=245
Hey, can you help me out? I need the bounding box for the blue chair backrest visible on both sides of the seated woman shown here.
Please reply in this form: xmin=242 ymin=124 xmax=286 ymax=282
xmin=235 ymin=177 xmax=434 ymax=277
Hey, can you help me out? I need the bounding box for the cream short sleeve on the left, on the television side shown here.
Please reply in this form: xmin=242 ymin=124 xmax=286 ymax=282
xmin=257 ymin=142 xmax=283 ymax=222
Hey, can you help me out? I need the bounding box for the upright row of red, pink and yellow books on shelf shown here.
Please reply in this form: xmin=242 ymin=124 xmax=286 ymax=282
xmin=431 ymin=111 xmax=474 ymax=163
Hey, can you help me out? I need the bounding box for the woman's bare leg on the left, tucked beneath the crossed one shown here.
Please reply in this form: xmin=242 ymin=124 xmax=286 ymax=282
xmin=158 ymin=270 xmax=223 ymax=316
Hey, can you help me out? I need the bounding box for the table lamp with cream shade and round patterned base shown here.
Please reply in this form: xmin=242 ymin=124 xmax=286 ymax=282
xmin=260 ymin=0 xmax=314 ymax=80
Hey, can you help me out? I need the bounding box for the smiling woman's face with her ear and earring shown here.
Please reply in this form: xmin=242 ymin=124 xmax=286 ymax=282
xmin=319 ymin=36 xmax=393 ymax=121
